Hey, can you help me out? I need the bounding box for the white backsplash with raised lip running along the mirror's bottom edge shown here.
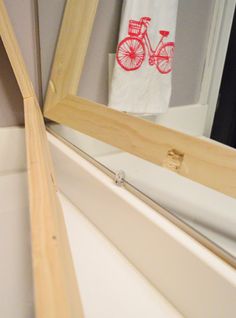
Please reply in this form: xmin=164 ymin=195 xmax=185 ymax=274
xmin=48 ymin=134 xmax=236 ymax=318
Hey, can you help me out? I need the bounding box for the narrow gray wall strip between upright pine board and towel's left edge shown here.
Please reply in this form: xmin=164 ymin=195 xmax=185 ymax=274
xmin=78 ymin=0 xmax=122 ymax=105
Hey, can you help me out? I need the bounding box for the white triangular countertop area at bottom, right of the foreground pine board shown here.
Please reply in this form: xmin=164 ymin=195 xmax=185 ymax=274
xmin=60 ymin=195 xmax=182 ymax=318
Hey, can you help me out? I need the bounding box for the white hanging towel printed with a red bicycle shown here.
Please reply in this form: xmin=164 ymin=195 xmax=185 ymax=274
xmin=108 ymin=0 xmax=178 ymax=115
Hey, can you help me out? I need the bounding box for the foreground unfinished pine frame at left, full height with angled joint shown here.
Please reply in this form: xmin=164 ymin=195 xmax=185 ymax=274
xmin=0 ymin=0 xmax=83 ymax=318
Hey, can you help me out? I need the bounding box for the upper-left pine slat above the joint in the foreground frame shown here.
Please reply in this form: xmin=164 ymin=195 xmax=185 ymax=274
xmin=0 ymin=0 xmax=35 ymax=98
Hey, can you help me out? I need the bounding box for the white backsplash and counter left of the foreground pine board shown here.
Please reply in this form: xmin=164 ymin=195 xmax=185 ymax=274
xmin=0 ymin=127 xmax=34 ymax=318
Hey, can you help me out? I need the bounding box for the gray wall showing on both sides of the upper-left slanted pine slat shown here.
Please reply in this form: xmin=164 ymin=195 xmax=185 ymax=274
xmin=0 ymin=0 xmax=40 ymax=127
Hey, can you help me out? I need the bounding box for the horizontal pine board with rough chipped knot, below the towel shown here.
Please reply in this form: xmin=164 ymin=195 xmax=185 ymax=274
xmin=45 ymin=95 xmax=236 ymax=197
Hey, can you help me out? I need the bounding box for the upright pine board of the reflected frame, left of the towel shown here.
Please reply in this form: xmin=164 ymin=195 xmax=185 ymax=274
xmin=44 ymin=0 xmax=98 ymax=110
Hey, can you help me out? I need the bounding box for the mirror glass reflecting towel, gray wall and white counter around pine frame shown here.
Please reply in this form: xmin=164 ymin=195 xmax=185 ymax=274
xmin=39 ymin=0 xmax=236 ymax=256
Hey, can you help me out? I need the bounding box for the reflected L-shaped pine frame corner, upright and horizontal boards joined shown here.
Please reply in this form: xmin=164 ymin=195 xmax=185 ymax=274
xmin=44 ymin=0 xmax=236 ymax=197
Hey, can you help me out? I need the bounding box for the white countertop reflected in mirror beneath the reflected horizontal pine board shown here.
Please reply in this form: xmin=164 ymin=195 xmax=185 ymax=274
xmin=96 ymin=153 xmax=236 ymax=241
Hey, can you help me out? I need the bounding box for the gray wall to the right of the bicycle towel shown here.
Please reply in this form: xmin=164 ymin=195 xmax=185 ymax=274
xmin=170 ymin=0 xmax=215 ymax=106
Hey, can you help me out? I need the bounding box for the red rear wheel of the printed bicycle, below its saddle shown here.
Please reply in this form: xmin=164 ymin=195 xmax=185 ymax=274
xmin=156 ymin=42 xmax=175 ymax=74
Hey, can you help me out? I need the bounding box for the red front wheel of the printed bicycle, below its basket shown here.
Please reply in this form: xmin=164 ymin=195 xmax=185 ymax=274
xmin=116 ymin=37 xmax=145 ymax=71
